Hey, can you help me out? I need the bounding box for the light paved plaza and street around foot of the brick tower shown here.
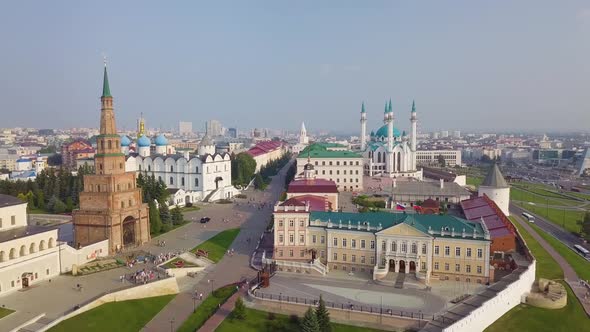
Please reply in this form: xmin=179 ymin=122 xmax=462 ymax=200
xmin=0 ymin=162 xmax=286 ymax=331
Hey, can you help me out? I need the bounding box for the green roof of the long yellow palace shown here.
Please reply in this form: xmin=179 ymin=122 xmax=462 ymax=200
xmin=309 ymin=211 xmax=485 ymax=240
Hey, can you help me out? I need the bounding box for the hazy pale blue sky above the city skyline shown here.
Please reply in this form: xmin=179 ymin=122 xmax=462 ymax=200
xmin=0 ymin=0 xmax=590 ymax=131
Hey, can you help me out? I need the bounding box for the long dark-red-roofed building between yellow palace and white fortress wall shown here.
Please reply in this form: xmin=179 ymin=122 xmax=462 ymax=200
xmin=461 ymin=195 xmax=516 ymax=253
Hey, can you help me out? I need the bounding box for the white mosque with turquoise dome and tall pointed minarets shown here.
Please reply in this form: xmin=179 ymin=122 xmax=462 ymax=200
xmin=361 ymin=100 xmax=422 ymax=180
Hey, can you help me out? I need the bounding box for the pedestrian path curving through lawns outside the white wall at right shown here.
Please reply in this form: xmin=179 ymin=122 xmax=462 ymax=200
xmin=514 ymin=216 xmax=590 ymax=316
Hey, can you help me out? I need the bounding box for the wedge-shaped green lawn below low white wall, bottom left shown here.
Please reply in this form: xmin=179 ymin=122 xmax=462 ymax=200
xmin=49 ymin=295 xmax=176 ymax=332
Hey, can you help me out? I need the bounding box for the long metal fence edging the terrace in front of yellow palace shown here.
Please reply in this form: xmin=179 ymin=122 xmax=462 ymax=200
xmin=252 ymin=291 xmax=434 ymax=320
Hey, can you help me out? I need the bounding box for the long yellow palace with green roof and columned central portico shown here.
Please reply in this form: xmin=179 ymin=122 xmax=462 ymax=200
xmin=273 ymin=205 xmax=494 ymax=284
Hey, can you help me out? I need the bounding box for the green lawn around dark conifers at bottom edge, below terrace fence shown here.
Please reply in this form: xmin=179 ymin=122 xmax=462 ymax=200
xmin=215 ymin=308 xmax=388 ymax=332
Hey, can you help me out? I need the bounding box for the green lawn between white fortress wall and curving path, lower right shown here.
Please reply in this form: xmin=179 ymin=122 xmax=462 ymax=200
xmin=485 ymin=217 xmax=590 ymax=332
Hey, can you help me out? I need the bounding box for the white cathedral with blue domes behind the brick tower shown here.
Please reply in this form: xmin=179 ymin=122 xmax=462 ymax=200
xmin=121 ymin=130 xmax=239 ymax=205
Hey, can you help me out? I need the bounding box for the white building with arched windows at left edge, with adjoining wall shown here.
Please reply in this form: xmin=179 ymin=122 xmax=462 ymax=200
xmin=0 ymin=195 xmax=108 ymax=295
